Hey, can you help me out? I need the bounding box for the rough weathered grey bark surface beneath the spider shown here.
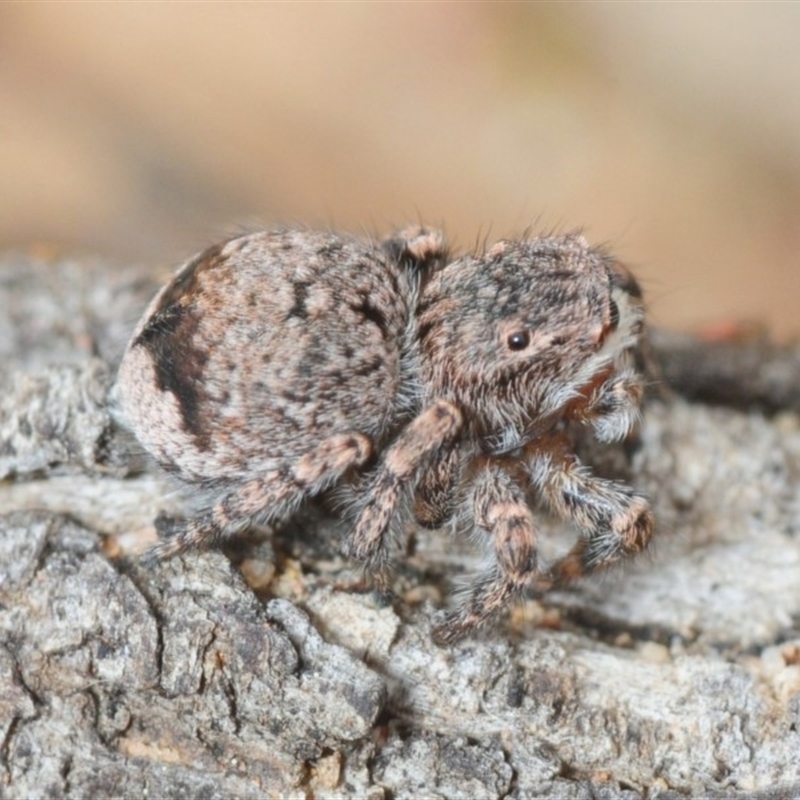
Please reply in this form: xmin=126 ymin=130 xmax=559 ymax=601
xmin=0 ymin=257 xmax=800 ymax=798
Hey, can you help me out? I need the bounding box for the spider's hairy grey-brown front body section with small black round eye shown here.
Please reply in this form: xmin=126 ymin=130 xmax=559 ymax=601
xmin=417 ymin=236 xmax=642 ymax=435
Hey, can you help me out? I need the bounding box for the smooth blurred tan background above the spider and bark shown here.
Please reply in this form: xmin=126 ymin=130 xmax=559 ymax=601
xmin=0 ymin=3 xmax=800 ymax=338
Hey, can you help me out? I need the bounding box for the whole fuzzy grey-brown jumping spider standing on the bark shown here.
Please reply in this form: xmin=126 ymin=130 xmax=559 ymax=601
xmin=116 ymin=223 xmax=653 ymax=642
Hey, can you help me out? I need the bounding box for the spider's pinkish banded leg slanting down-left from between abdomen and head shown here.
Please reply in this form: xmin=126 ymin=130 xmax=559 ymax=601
xmin=342 ymin=400 xmax=463 ymax=591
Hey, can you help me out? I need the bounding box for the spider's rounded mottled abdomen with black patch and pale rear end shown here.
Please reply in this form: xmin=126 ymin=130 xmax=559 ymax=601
xmin=119 ymin=231 xmax=413 ymax=483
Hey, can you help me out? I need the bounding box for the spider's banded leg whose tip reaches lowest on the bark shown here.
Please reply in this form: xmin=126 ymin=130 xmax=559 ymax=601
xmin=434 ymin=463 xmax=538 ymax=644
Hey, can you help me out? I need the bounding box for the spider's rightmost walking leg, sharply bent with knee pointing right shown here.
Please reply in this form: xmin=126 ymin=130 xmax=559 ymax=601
xmin=524 ymin=436 xmax=654 ymax=586
